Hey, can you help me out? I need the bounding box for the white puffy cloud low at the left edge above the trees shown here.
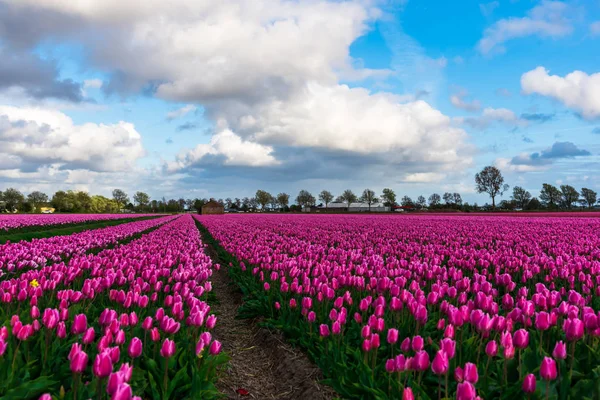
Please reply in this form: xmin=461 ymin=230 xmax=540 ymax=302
xmin=0 ymin=106 xmax=145 ymax=172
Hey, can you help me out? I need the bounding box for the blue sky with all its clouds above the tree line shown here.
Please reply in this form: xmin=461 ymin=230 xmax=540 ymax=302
xmin=0 ymin=0 xmax=600 ymax=204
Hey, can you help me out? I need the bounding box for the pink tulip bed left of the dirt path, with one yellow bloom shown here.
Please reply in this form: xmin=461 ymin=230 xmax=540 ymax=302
xmin=0 ymin=216 xmax=226 ymax=400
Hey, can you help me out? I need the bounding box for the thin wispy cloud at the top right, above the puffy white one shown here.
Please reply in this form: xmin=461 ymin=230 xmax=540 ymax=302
xmin=477 ymin=0 xmax=573 ymax=54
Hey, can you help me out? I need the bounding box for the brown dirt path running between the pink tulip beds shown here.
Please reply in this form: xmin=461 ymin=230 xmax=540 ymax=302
xmin=206 ymin=242 xmax=336 ymax=400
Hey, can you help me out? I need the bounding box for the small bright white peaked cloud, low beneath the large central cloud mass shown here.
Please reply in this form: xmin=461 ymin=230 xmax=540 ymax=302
xmin=167 ymin=129 xmax=279 ymax=172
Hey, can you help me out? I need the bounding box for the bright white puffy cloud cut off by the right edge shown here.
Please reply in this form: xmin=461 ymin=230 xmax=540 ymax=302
xmin=521 ymin=67 xmax=600 ymax=119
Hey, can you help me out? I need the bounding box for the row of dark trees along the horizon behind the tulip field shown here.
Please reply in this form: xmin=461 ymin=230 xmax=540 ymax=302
xmin=0 ymin=166 xmax=598 ymax=213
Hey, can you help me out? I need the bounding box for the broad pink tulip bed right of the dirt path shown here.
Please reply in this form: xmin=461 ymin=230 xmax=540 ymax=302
xmin=196 ymin=215 xmax=600 ymax=400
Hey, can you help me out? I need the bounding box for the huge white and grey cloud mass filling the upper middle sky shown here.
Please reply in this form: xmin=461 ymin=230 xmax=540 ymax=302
xmin=0 ymin=0 xmax=472 ymax=184
